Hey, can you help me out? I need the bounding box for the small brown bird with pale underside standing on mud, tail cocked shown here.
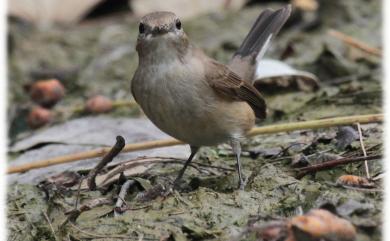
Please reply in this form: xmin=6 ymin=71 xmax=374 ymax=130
xmin=131 ymin=5 xmax=291 ymax=189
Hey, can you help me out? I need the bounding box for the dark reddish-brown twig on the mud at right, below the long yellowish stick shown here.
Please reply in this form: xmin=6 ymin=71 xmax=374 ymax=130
xmin=295 ymin=155 xmax=382 ymax=179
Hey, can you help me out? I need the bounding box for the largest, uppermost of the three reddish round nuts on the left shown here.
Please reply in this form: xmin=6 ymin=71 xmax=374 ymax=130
xmin=29 ymin=79 xmax=65 ymax=108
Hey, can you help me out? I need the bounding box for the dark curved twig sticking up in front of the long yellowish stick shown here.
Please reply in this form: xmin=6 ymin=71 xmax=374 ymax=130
xmin=88 ymin=136 xmax=125 ymax=190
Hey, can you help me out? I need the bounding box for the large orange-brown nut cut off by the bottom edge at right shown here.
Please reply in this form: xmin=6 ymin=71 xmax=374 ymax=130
xmin=287 ymin=209 xmax=356 ymax=241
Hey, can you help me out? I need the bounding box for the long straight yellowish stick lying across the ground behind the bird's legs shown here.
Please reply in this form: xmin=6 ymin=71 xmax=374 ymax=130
xmin=7 ymin=114 xmax=384 ymax=174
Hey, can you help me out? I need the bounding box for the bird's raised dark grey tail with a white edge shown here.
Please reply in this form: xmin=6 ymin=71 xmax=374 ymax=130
xmin=229 ymin=4 xmax=291 ymax=81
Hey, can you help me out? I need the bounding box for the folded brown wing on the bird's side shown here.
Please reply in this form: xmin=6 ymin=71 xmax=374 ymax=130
xmin=206 ymin=61 xmax=266 ymax=119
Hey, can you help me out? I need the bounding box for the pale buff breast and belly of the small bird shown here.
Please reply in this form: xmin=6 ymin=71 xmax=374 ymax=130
xmin=132 ymin=57 xmax=254 ymax=146
